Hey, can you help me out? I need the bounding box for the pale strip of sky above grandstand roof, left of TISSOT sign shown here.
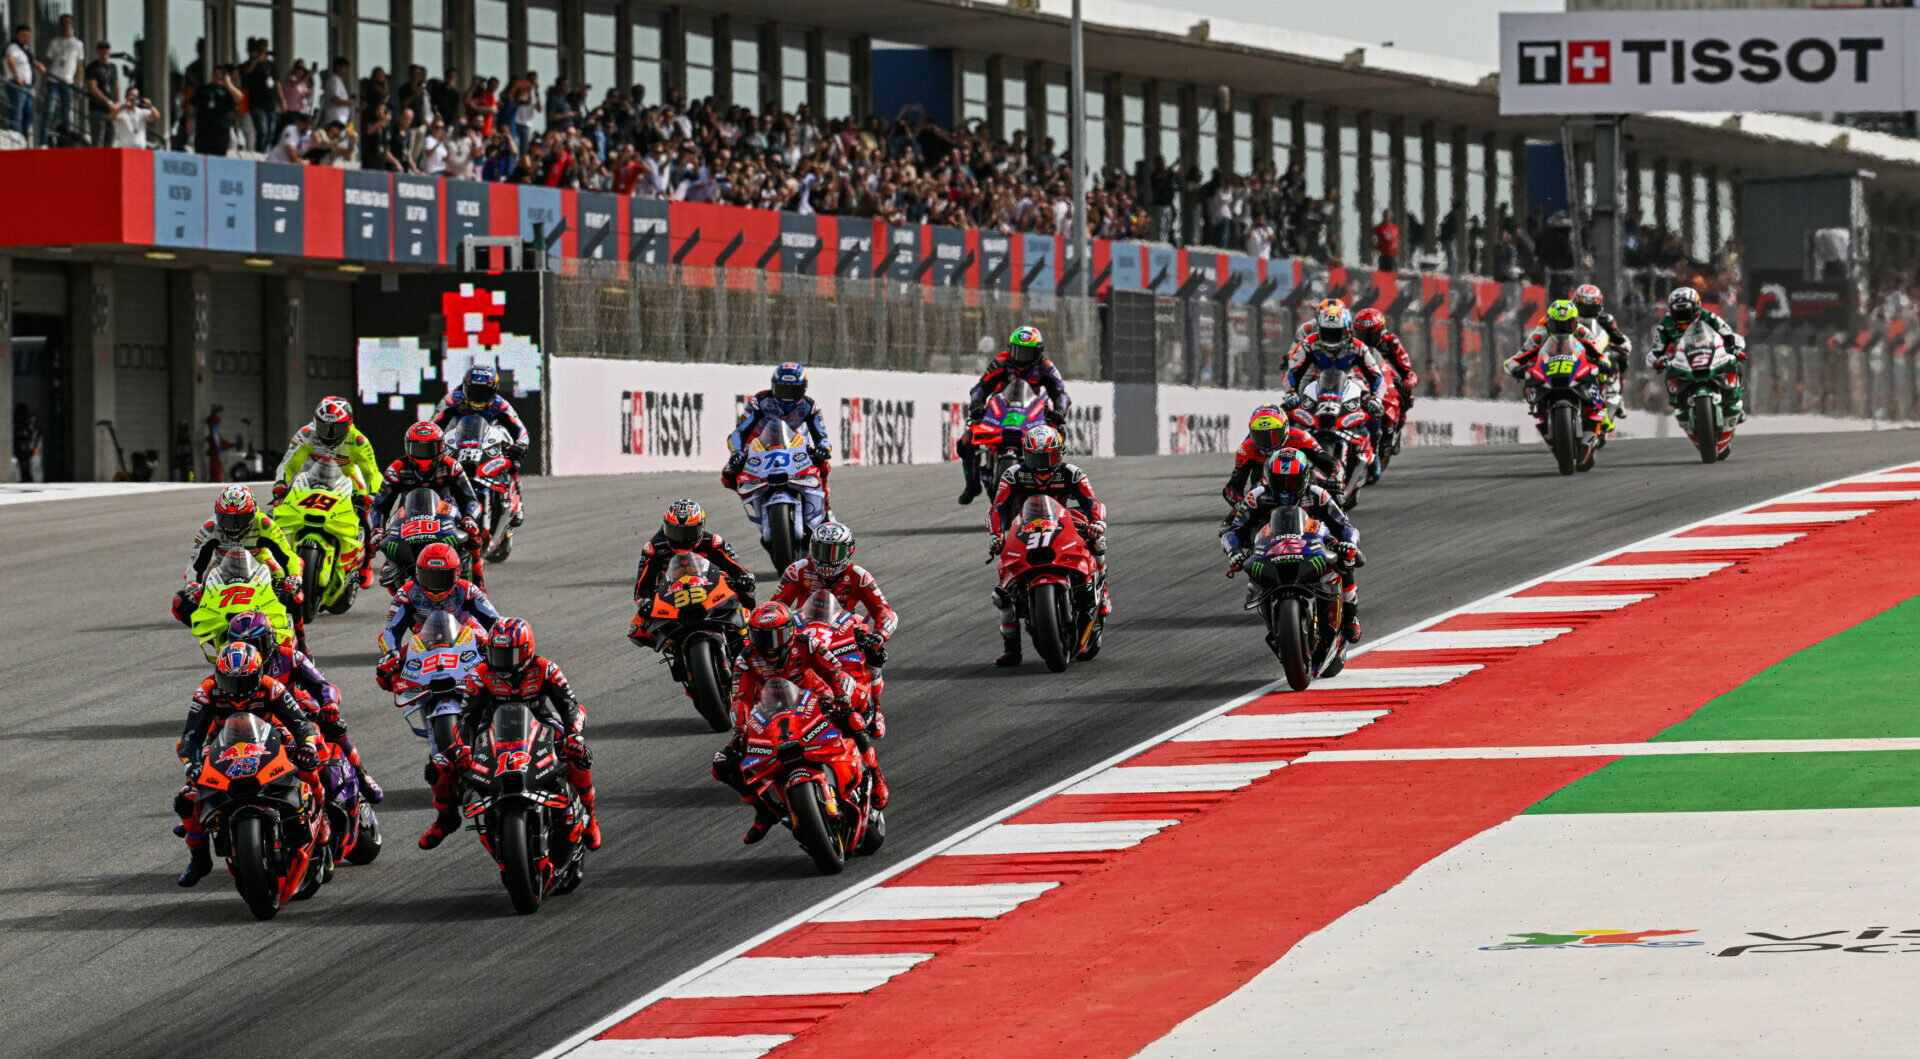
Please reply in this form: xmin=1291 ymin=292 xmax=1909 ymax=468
xmin=1144 ymin=0 xmax=1567 ymax=67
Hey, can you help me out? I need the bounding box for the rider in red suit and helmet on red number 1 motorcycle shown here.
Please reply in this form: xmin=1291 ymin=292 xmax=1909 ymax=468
xmin=710 ymin=600 xmax=887 ymax=846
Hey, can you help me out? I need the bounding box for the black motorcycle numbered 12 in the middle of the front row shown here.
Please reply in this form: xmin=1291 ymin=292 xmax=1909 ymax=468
xmin=461 ymin=700 xmax=588 ymax=915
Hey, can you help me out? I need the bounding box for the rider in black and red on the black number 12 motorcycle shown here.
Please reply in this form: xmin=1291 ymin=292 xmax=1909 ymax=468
xmin=420 ymin=618 xmax=601 ymax=850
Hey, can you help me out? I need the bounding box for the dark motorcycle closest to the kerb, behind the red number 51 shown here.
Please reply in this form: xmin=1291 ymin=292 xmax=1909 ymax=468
xmin=1244 ymin=505 xmax=1348 ymax=691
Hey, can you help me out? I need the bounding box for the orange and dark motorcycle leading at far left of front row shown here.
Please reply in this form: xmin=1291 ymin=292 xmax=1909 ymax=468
xmin=194 ymin=712 xmax=334 ymax=919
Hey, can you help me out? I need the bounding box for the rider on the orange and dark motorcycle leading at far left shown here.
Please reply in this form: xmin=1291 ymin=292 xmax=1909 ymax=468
xmin=173 ymin=643 xmax=324 ymax=886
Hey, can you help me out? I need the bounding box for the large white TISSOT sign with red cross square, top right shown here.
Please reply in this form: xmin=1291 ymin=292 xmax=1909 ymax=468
xmin=1500 ymin=10 xmax=1920 ymax=113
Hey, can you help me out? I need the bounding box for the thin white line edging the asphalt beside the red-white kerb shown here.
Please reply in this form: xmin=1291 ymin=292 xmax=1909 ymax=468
xmin=536 ymin=460 xmax=1920 ymax=1059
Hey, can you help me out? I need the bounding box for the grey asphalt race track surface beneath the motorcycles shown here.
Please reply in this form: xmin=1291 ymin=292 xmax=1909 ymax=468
xmin=11 ymin=432 xmax=1920 ymax=1057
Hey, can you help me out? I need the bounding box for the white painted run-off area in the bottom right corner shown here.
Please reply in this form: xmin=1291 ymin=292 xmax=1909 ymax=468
xmin=1140 ymin=808 xmax=1920 ymax=1059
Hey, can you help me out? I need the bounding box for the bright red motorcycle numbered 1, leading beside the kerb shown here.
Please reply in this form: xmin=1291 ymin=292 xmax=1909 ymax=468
xmin=741 ymin=679 xmax=887 ymax=875
